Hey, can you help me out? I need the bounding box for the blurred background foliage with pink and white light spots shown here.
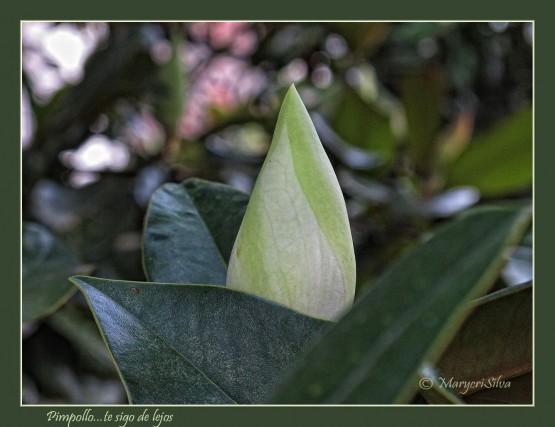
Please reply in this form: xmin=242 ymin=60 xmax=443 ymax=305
xmin=22 ymin=22 xmax=533 ymax=404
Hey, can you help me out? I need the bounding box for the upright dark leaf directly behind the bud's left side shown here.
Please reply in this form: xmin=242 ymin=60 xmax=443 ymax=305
xmin=143 ymin=179 xmax=249 ymax=286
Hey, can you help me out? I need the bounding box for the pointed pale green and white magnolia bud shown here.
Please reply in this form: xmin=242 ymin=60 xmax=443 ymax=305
xmin=227 ymin=86 xmax=356 ymax=319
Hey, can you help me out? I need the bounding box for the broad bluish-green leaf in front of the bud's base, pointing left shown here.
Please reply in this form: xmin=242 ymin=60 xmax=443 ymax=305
xmin=72 ymin=276 xmax=328 ymax=404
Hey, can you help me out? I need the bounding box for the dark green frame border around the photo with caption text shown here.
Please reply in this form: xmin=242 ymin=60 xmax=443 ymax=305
xmin=4 ymin=0 xmax=555 ymax=427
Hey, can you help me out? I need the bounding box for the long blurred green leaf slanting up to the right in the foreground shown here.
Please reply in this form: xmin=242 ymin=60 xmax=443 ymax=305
xmin=271 ymin=208 xmax=530 ymax=403
